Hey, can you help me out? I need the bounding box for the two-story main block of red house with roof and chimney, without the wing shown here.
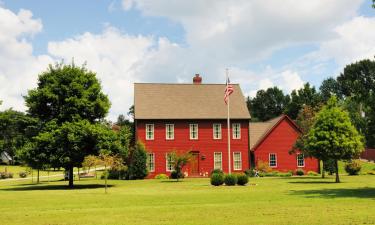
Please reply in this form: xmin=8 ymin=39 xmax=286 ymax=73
xmin=134 ymin=74 xmax=250 ymax=177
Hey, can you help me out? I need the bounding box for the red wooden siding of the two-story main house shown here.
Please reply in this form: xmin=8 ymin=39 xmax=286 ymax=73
xmin=136 ymin=120 xmax=249 ymax=177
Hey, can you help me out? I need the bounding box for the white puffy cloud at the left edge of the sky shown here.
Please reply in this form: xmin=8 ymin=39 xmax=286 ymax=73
xmin=0 ymin=7 xmax=52 ymax=110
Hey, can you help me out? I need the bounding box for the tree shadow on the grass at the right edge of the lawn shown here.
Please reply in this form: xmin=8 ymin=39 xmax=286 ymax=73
xmin=291 ymin=187 xmax=375 ymax=200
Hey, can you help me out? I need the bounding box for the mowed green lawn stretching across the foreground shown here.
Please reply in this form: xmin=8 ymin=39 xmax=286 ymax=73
xmin=0 ymin=175 xmax=375 ymax=225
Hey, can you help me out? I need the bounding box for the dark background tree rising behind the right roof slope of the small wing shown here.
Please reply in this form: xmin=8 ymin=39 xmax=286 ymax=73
xmin=284 ymin=83 xmax=322 ymax=120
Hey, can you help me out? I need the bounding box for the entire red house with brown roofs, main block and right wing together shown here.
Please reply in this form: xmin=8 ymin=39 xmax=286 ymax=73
xmin=134 ymin=75 xmax=319 ymax=177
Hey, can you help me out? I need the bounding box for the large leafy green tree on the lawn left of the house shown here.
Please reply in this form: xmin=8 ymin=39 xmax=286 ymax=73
xmin=24 ymin=63 xmax=111 ymax=187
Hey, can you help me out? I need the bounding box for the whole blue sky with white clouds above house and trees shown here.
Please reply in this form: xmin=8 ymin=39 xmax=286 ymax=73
xmin=0 ymin=0 xmax=375 ymax=119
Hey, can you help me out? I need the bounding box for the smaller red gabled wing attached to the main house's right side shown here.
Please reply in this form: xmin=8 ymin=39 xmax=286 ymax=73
xmin=250 ymin=115 xmax=319 ymax=172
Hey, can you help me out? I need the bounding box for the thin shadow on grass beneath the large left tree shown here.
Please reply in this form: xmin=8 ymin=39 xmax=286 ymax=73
xmin=0 ymin=184 xmax=115 ymax=191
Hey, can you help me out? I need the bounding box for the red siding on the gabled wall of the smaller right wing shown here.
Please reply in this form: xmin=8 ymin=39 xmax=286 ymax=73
xmin=254 ymin=117 xmax=319 ymax=172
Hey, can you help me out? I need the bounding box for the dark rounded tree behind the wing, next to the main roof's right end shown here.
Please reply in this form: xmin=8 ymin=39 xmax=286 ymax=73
xmin=247 ymin=87 xmax=289 ymax=121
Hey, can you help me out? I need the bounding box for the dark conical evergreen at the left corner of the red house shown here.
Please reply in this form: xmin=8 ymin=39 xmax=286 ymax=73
xmin=128 ymin=141 xmax=148 ymax=180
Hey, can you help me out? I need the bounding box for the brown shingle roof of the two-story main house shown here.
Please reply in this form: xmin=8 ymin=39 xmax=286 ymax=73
xmin=134 ymin=83 xmax=250 ymax=119
